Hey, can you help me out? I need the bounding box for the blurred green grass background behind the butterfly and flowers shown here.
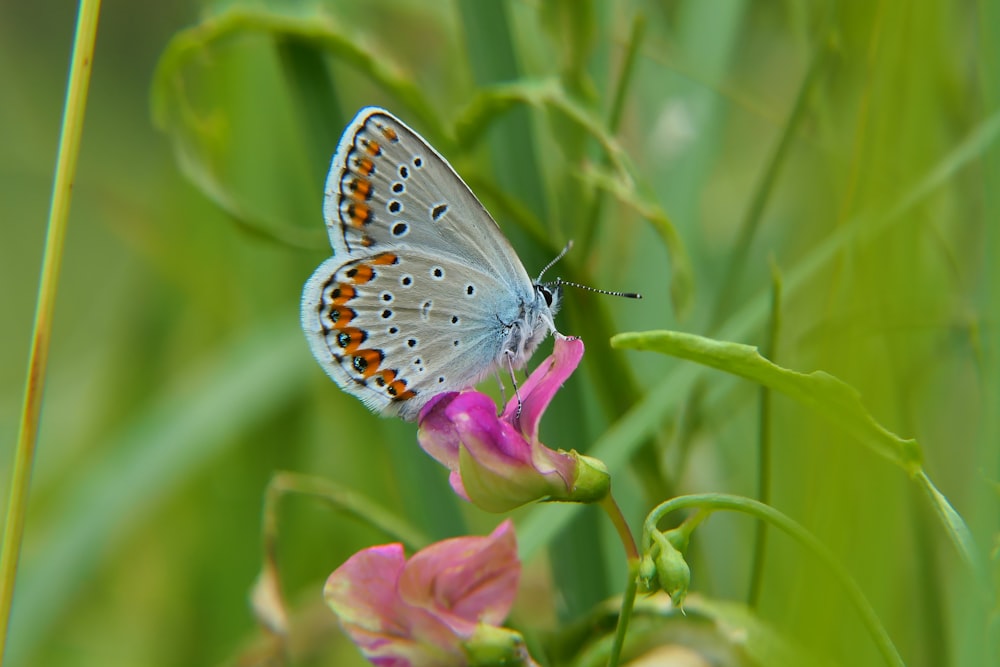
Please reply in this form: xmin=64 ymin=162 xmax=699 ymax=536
xmin=0 ymin=0 xmax=1000 ymax=667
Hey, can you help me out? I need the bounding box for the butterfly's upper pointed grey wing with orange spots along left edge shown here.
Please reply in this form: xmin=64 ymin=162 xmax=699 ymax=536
xmin=323 ymin=107 xmax=532 ymax=294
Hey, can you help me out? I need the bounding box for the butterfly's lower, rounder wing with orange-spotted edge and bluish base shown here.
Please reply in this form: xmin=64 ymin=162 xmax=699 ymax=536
xmin=302 ymin=249 xmax=522 ymax=420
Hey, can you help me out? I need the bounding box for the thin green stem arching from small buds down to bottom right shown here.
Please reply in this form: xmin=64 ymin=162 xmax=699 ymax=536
xmin=642 ymin=493 xmax=905 ymax=667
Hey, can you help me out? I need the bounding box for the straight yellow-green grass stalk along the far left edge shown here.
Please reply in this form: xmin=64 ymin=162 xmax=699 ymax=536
xmin=0 ymin=0 xmax=101 ymax=665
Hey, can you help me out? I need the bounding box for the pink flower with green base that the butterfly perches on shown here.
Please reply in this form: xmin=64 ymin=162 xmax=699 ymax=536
xmin=417 ymin=334 xmax=610 ymax=512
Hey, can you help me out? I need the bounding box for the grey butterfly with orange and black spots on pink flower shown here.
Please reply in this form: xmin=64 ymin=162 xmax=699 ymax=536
xmin=302 ymin=107 xmax=562 ymax=421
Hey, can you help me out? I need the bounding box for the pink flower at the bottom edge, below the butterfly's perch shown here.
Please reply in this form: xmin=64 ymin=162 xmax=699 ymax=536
xmin=323 ymin=521 xmax=535 ymax=667
